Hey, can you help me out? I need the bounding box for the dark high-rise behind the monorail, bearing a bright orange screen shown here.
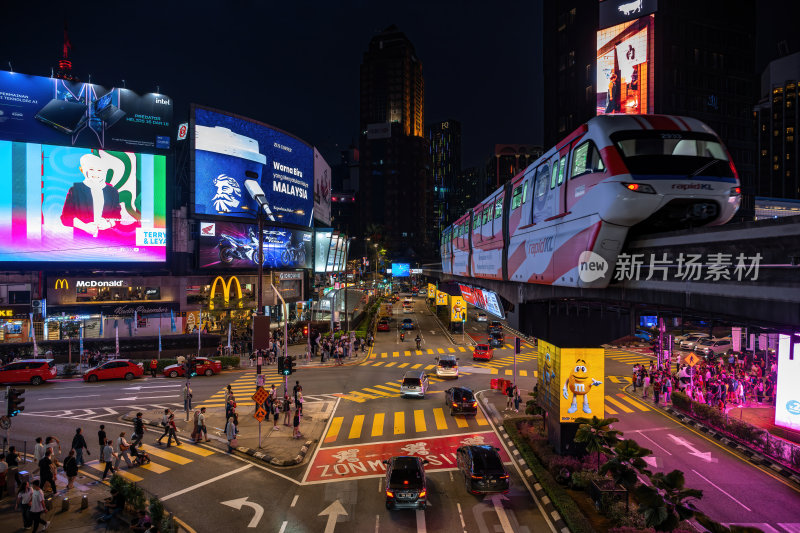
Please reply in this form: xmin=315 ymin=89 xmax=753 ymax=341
xmin=543 ymin=0 xmax=756 ymax=218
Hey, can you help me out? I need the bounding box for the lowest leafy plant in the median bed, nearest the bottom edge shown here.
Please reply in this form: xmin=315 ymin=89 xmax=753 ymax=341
xmin=634 ymin=470 xmax=703 ymax=531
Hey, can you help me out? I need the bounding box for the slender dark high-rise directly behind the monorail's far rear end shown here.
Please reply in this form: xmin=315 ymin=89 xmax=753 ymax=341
xmin=428 ymin=119 xmax=461 ymax=235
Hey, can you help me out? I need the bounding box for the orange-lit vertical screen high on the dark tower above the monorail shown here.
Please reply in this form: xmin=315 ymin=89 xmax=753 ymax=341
xmin=596 ymin=15 xmax=655 ymax=115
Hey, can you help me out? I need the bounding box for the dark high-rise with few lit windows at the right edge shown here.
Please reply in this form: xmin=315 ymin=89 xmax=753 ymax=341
xmin=753 ymin=52 xmax=800 ymax=200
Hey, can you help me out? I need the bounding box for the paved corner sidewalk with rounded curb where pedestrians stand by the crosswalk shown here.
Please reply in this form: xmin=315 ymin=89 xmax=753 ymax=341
xmin=122 ymin=398 xmax=336 ymax=466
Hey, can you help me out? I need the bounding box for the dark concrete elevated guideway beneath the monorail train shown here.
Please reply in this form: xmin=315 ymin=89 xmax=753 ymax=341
xmin=424 ymin=217 xmax=800 ymax=342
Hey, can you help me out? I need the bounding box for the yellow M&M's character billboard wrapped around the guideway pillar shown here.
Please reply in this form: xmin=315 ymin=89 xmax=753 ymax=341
xmin=538 ymin=339 xmax=605 ymax=423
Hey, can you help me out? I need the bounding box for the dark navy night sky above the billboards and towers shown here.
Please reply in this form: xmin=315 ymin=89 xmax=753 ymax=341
xmin=0 ymin=0 xmax=542 ymax=166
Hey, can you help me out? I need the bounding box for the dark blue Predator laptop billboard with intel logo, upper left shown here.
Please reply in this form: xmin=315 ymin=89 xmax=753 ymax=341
xmin=0 ymin=71 xmax=174 ymax=153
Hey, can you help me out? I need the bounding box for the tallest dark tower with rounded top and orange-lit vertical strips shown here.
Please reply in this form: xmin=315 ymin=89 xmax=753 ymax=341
xmin=359 ymin=26 xmax=437 ymax=258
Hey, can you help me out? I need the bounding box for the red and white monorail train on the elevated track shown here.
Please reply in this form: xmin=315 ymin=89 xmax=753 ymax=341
xmin=441 ymin=115 xmax=741 ymax=288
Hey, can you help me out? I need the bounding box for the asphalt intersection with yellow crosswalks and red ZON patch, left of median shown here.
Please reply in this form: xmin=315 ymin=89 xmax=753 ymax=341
xmin=11 ymin=298 xmax=552 ymax=533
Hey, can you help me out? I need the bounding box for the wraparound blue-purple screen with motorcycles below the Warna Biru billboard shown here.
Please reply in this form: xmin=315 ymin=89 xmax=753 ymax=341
xmin=198 ymin=222 xmax=312 ymax=269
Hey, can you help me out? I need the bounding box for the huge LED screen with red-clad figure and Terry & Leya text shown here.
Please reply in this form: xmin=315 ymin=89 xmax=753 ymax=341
xmin=0 ymin=141 xmax=167 ymax=263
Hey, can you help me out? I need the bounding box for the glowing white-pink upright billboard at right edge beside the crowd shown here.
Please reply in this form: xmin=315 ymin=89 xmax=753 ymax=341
xmin=775 ymin=334 xmax=800 ymax=431
